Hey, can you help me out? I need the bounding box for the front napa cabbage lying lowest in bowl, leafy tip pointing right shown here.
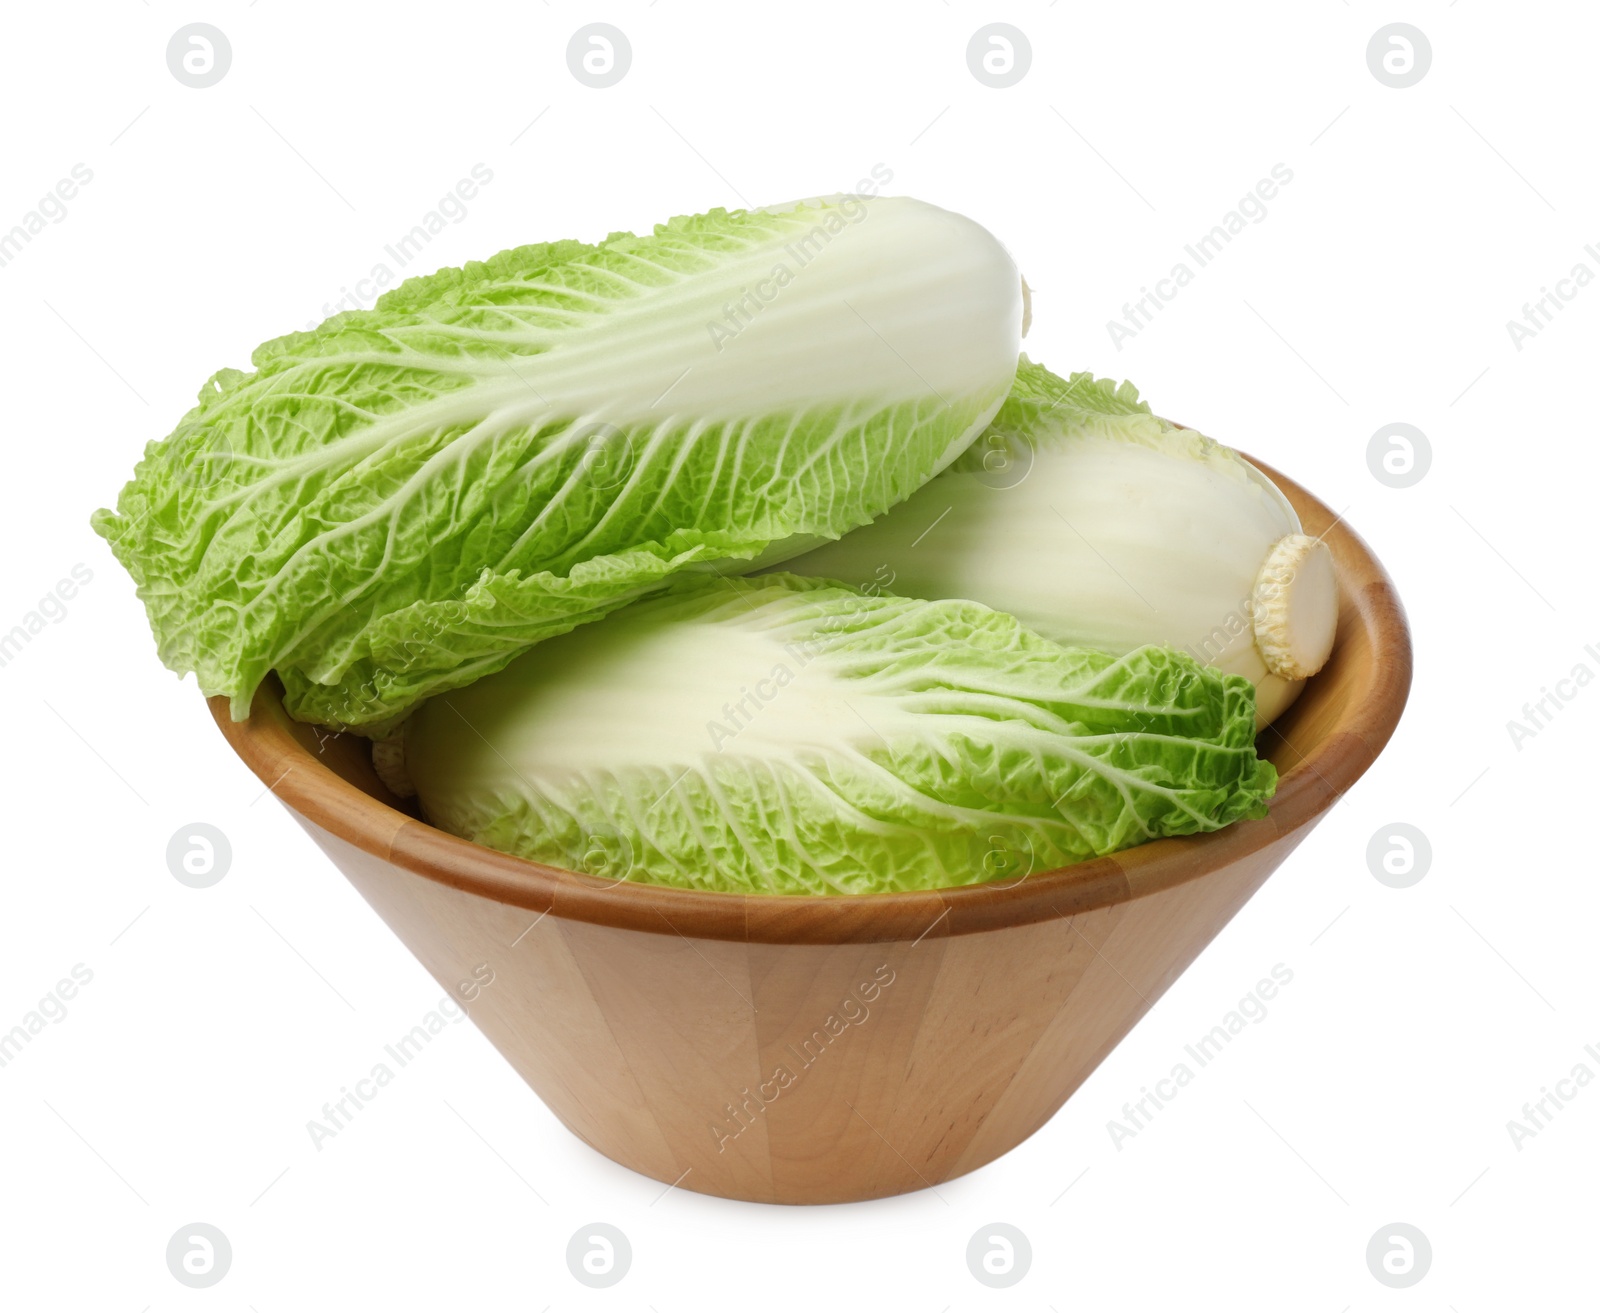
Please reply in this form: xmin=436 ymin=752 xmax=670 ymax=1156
xmin=403 ymin=574 xmax=1277 ymax=894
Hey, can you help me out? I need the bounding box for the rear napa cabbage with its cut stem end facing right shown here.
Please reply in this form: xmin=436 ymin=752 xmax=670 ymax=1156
xmin=786 ymin=357 xmax=1338 ymax=726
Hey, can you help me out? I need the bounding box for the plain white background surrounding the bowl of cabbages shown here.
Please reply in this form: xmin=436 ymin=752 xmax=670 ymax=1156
xmin=0 ymin=0 xmax=1600 ymax=1313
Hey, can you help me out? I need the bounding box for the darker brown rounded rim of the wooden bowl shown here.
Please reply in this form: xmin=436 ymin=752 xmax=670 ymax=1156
xmin=208 ymin=457 xmax=1411 ymax=945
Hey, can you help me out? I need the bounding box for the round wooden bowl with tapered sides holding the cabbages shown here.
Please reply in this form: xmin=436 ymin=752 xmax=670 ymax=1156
xmin=211 ymin=467 xmax=1411 ymax=1204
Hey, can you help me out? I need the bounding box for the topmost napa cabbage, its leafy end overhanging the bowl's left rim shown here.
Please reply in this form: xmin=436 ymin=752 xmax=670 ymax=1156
xmin=94 ymin=197 xmax=1022 ymax=734
